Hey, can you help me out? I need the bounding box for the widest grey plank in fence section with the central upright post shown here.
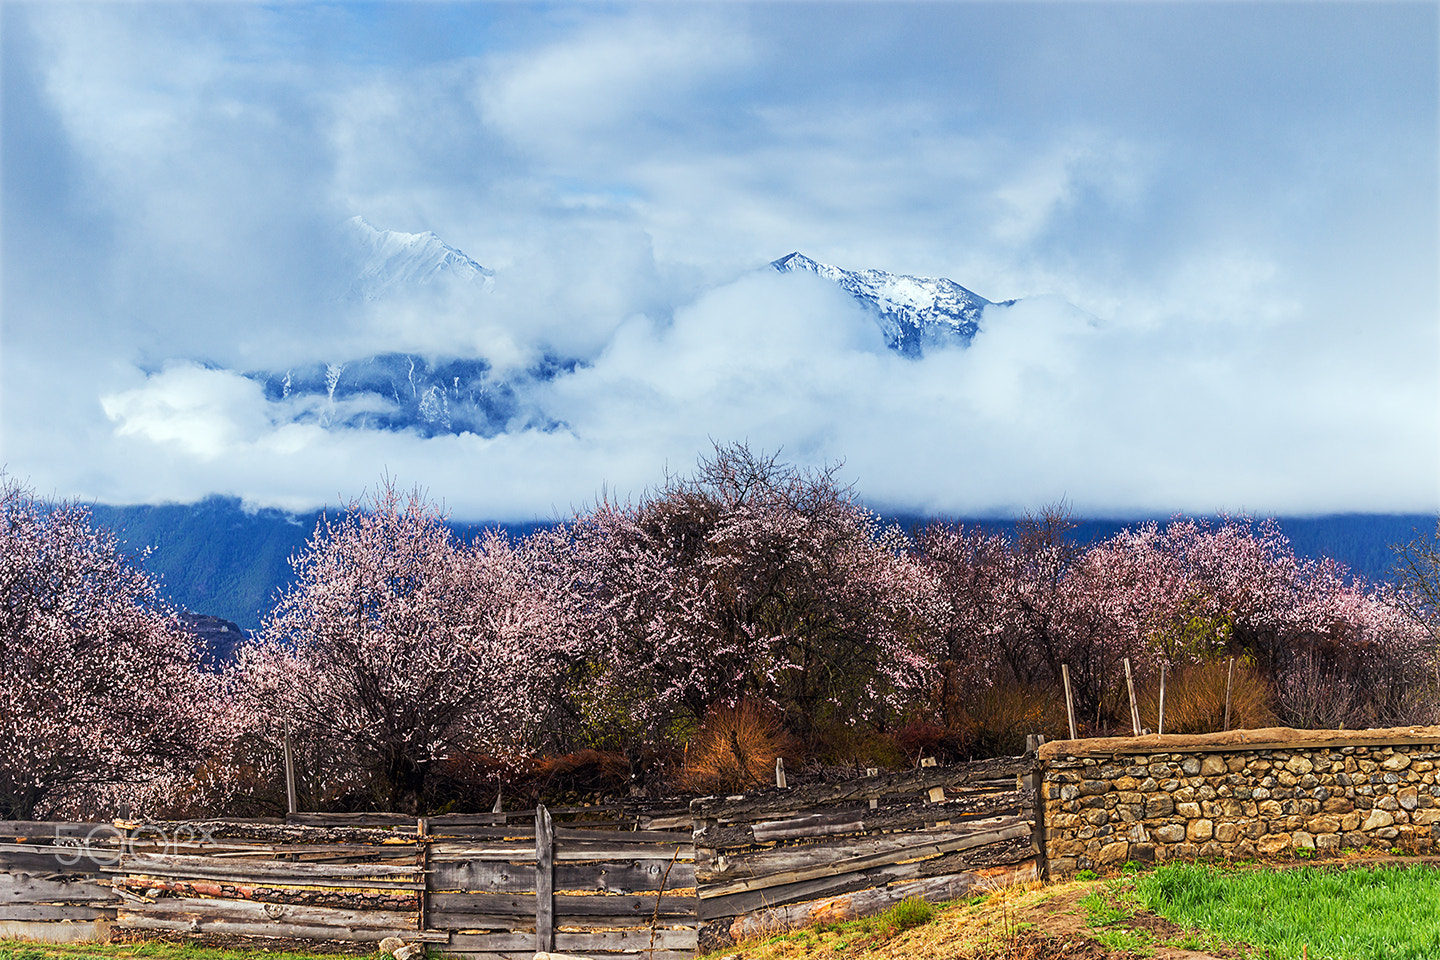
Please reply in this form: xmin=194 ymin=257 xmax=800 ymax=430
xmin=429 ymin=859 xmax=696 ymax=894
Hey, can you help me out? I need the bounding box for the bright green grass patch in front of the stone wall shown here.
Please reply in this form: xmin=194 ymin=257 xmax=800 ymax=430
xmin=1133 ymin=864 xmax=1440 ymax=960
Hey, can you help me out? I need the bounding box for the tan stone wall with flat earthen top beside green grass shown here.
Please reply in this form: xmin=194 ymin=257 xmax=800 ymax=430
xmin=1040 ymin=727 xmax=1440 ymax=877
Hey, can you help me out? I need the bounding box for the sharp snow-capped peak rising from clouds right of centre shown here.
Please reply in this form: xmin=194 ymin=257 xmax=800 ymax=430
xmin=770 ymin=253 xmax=1014 ymax=357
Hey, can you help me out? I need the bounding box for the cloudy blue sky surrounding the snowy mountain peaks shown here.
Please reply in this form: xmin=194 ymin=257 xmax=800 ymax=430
xmin=0 ymin=0 xmax=1440 ymax=521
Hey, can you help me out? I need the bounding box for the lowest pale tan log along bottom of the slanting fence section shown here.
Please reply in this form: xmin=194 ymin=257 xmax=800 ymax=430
xmin=730 ymin=861 xmax=1038 ymax=943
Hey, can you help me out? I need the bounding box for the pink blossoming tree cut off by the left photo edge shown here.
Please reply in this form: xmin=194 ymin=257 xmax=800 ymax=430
xmin=0 ymin=475 xmax=223 ymax=819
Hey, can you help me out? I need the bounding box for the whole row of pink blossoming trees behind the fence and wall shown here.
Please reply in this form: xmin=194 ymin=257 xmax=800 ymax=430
xmin=0 ymin=445 xmax=1440 ymax=818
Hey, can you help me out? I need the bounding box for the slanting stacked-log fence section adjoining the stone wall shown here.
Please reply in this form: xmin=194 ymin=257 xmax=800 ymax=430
xmin=691 ymin=756 xmax=1043 ymax=948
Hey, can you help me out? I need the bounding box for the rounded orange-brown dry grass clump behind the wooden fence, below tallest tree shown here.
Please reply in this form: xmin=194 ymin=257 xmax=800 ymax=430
xmin=677 ymin=701 xmax=795 ymax=793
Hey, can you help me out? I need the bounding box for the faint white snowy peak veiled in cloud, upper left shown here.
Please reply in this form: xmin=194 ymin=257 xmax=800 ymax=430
xmin=341 ymin=217 xmax=495 ymax=301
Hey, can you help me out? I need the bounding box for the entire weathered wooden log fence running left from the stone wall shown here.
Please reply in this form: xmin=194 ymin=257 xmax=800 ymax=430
xmin=0 ymin=756 xmax=1037 ymax=960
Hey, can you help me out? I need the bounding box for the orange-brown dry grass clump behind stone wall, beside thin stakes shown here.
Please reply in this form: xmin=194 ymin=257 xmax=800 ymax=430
xmin=1140 ymin=659 xmax=1276 ymax=734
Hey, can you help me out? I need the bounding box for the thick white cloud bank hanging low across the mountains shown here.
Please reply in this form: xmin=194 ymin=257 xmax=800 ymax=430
xmin=92 ymin=266 xmax=1440 ymax=518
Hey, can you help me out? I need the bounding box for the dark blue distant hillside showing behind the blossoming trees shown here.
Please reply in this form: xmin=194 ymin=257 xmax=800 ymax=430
xmin=94 ymin=497 xmax=1434 ymax=630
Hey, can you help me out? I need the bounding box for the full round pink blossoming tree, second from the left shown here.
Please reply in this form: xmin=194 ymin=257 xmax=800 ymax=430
xmin=236 ymin=484 xmax=543 ymax=809
